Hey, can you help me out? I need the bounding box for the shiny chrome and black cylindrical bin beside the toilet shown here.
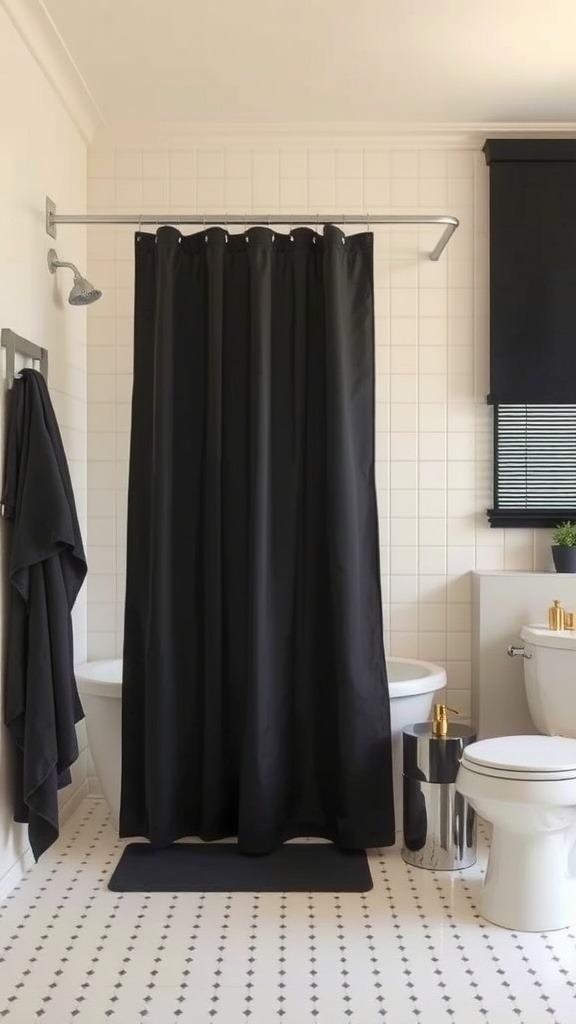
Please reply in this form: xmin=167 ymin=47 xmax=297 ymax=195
xmin=402 ymin=722 xmax=476 ymax=871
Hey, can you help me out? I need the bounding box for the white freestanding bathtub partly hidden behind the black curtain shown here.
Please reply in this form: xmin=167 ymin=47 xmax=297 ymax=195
xmin=76 ymin=657 xmax=446 ymax=830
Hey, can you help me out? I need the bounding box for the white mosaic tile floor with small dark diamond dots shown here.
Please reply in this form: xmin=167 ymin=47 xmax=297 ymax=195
xmin=0 ymin=800 xmax=576 ymax=1024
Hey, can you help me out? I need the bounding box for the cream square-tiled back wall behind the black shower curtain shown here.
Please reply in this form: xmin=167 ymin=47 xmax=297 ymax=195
xmin=84 ymin=133 xmax=549 ymax=716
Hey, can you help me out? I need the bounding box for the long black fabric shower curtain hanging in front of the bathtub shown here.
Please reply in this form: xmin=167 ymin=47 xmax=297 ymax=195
xmin=120 ymin=225 xmax=395 ymax=853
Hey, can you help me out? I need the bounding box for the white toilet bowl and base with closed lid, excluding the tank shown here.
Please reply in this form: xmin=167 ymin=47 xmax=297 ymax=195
xmin=456 ymin=736 xmax=576 ymax=932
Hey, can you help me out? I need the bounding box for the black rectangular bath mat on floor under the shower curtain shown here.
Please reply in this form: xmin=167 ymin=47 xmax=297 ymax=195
xmin=108 ymin=843 xmax=372 ymax=893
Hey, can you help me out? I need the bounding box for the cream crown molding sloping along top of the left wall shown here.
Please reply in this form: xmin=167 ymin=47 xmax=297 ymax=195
xmin=0 ymin=0 xmax=104 ymax=142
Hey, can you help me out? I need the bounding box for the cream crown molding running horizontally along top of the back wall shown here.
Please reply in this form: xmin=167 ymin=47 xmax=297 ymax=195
xmin=93 ymin=122 xmax=576 ymax=150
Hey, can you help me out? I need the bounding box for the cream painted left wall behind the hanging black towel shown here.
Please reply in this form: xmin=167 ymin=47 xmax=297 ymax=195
xmin=0 ymin=7 xmax=86 ymax=891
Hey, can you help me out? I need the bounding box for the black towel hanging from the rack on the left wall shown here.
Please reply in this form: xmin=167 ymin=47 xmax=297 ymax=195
xmin=2 ymin=370 xmax=86 ymax=860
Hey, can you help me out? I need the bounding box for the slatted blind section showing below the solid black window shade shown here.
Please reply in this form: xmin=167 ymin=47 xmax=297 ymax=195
xmin=494 ymin=404 xmax=576 ymax=512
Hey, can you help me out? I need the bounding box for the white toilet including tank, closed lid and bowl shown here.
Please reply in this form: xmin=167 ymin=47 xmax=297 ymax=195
xmin=456 ymin=626 xmax=576 ymax=932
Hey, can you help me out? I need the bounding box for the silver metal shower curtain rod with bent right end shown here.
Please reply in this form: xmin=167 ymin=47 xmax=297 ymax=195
xmin=46 ymin=198 xmax=459 ymax=261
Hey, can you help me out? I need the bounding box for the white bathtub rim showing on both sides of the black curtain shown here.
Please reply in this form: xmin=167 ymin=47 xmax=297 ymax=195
xmin=75 ymin=657 xmax=447 ymax=700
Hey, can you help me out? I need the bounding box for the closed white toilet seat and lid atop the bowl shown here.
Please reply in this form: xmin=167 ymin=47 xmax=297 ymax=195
xmin=461 ymin=736 xmax=576 ymax=782
